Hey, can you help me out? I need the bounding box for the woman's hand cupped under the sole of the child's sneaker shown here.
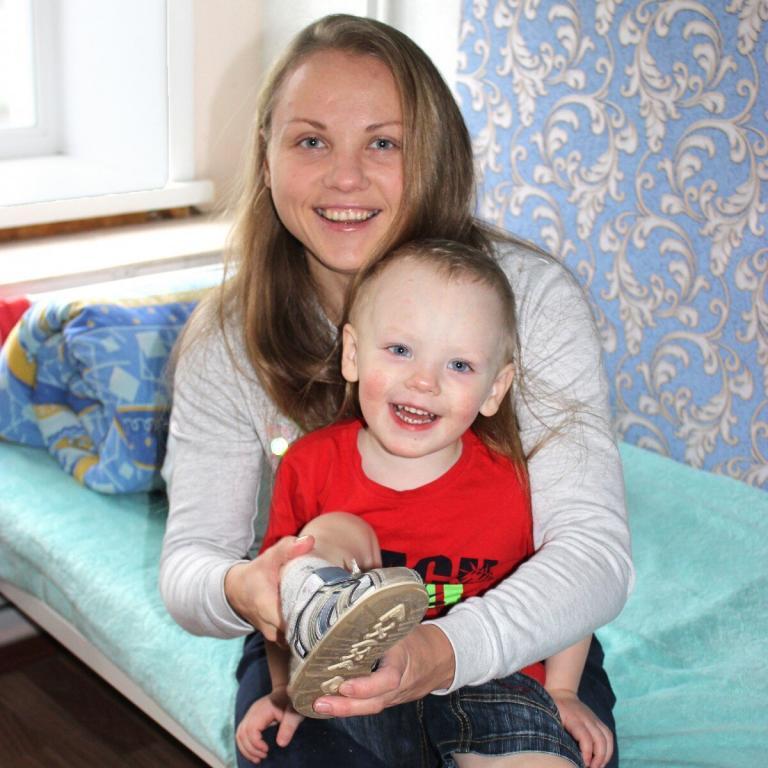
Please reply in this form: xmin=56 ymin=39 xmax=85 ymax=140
xmin=314 ymin=624 xmax=455 ymax=717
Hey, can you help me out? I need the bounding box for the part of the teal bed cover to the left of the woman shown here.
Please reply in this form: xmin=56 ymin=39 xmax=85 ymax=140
xmin=0 ymin=444 xmax=243 ymax=764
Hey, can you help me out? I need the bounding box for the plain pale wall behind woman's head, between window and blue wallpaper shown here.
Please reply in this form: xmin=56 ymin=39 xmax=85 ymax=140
xmin=194 ymin=0 xmax=460 ymax=210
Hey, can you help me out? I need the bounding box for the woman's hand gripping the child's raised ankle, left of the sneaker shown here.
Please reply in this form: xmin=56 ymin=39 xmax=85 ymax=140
xmin=224 ymin=536 xmax=315 ymax=641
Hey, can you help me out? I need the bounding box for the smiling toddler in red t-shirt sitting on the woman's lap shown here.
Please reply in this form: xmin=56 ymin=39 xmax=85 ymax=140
xmin=237 ymin=241 xmax=611 ymax=768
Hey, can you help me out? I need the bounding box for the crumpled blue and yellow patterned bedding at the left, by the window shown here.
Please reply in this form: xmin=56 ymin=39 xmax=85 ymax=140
xmin=0 ymin=290 xmax=202 ymax=493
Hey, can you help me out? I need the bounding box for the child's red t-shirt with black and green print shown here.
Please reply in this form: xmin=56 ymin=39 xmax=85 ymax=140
xmin=262 ymin=421 xmax=544 ymax=683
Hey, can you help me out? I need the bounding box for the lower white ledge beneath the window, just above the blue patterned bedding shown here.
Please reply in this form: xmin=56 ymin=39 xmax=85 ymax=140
xmin=0 ymin=216 xmax=230 ymax=298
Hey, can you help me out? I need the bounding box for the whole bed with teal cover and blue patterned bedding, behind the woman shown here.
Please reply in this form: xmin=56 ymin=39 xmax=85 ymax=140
xmin=0 ymin=269 xmax=768 ymax=768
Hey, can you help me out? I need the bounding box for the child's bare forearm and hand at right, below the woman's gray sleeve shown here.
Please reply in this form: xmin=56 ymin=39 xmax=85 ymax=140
xmin=544 ymin=635 xmax=613 ymax=768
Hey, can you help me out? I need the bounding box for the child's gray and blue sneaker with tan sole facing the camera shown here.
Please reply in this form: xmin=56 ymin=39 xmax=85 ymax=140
xmin=288 ymin=568 xmax=428 ymax=718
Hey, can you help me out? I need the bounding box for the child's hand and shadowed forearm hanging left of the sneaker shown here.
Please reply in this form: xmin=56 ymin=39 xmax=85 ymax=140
xmin=236 ymin=641 xmax=304 ymax=763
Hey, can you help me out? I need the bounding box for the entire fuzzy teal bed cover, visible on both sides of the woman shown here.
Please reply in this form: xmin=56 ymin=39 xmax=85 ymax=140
xmin=0 ymin=444 xmax=768 ymax=768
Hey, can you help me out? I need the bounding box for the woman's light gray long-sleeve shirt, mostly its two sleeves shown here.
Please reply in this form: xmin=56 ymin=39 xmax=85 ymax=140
xmin=160 ymin=240 xmax=633 ymax=690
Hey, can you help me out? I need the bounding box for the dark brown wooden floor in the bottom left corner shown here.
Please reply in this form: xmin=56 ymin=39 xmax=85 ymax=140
xmin=0 ymin=636 xmax=206 ymax=768
